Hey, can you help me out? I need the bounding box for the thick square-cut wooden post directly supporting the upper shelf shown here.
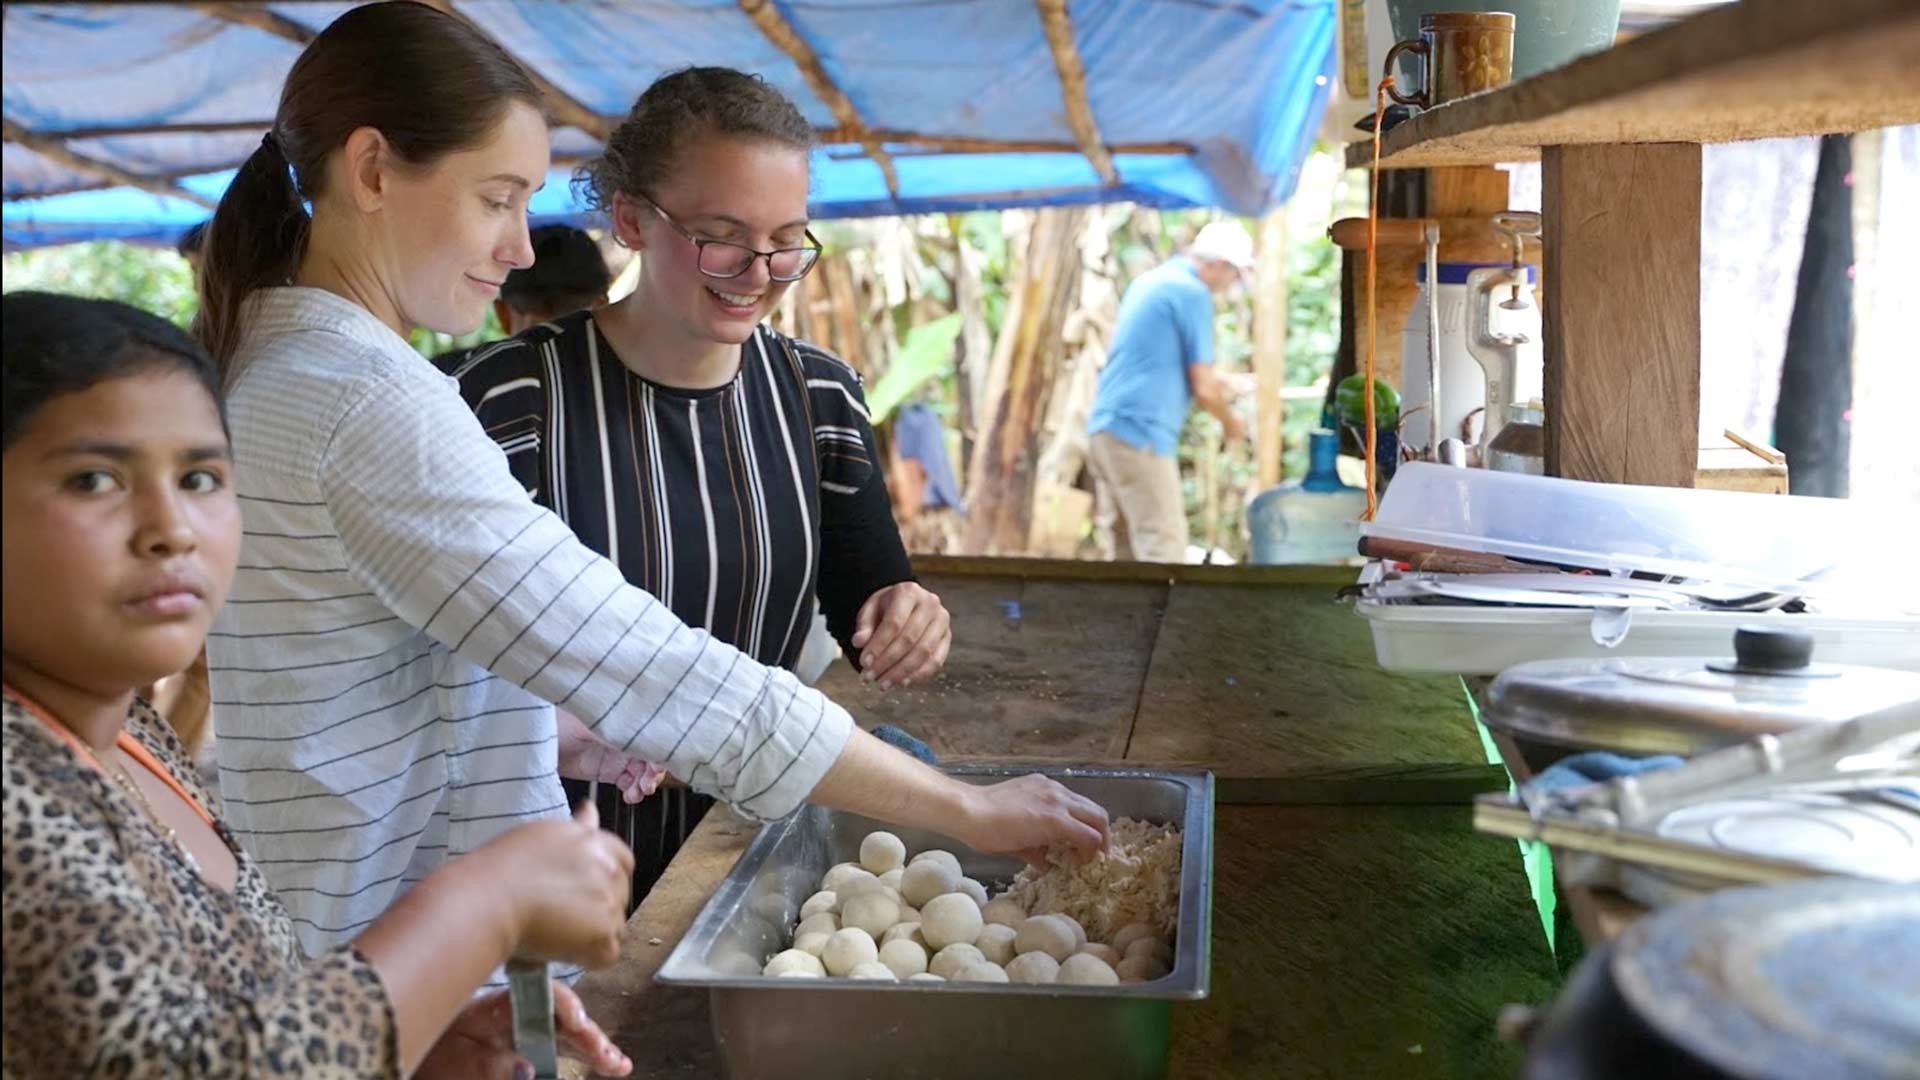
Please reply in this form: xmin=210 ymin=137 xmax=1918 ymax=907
xmin=1540 ymin=142 xmax=1701 ymax=488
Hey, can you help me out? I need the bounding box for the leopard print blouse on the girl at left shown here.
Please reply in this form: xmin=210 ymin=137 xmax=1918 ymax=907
xmin=0 ymin=700 xmax=399 ymax=1080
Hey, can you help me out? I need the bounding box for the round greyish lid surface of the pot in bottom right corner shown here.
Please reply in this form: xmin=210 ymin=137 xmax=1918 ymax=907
xmin=1609 ymin=878 xmax=1920 ymax=1080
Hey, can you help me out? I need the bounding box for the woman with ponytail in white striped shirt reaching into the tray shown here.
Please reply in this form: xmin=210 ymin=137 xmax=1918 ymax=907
xmin=200 ymin=0 xmax=1106 ymax=983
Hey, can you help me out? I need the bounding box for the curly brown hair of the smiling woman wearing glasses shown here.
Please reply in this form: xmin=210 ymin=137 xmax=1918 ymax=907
xmin=574 ymin=67 xmax=814 ymax=211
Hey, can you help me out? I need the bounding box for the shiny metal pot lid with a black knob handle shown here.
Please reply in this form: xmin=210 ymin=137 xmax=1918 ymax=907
xmin=1484 ymin=626 xmax=1920 ymax=755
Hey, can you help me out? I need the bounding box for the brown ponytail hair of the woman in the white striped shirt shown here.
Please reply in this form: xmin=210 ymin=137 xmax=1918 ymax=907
xmin=194 ymin=0 xmax=543 ymax=386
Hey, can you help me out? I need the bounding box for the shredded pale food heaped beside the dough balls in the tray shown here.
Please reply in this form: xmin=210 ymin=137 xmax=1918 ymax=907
xmin=1006 ymin=817 xmax=1181 ymax=942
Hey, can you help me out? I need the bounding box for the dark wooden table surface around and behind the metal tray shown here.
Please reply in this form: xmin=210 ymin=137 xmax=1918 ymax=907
xmin=580 ymin=559 xmax=1555 ymax=1078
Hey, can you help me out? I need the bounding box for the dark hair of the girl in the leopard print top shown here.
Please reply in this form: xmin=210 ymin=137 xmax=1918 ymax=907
xmin=0 ymin=290 xmax=227 ymax=450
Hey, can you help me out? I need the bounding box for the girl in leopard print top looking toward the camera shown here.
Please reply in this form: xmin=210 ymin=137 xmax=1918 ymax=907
xmin=0 ymin=292 xmax=632 ymax=1080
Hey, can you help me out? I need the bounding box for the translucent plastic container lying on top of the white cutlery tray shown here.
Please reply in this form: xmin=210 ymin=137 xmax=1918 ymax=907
xmin=1361 ymin=461 xmax=1920 ymax=599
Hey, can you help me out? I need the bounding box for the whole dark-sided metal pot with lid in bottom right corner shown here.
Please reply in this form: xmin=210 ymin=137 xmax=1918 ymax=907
xmin=1523 ymin=878 xmax=1920 ymax=1080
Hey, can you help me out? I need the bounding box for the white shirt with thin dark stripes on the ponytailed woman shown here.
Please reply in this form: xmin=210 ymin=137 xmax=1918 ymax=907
xmin=207 ymin=288 xmax=852 ymax=953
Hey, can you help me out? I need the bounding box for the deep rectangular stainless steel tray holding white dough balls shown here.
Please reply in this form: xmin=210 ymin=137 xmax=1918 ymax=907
xmin=655 ymin=765 xmax=1213 ymax=1080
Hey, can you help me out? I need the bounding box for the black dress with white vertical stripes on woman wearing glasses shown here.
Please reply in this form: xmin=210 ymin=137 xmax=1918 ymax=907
xmin=438 ymin=311 xmax=912 ymax=903
